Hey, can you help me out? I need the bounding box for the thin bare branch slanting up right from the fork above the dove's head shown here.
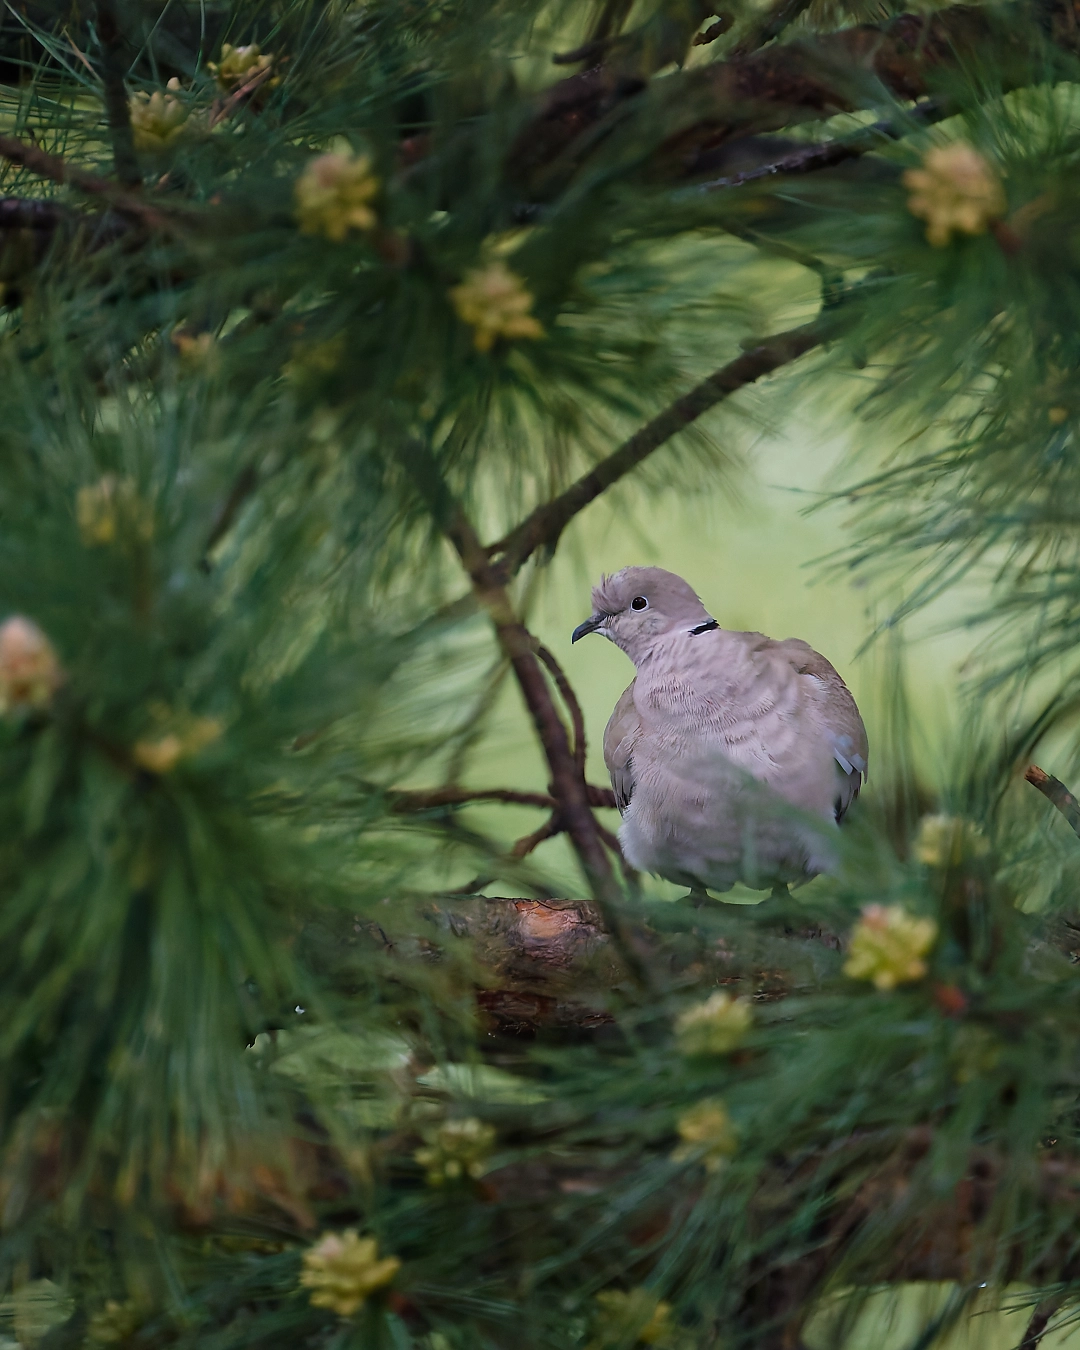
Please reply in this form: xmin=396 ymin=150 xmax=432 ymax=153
xmin=487 ymin=321 xmax=830 ymax=583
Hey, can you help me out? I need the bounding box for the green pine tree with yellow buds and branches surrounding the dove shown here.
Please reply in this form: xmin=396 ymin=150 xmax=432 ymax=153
xmin=0 ymin=0 xmax=1080 ymax=1350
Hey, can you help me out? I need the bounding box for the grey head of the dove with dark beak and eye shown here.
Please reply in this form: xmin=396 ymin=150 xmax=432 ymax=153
xmin=571 ymin=567 xmax=716 ymax=664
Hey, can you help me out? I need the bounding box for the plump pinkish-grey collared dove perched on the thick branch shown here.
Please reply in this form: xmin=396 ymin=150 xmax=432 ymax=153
xmin=572 ymin=567 xmax=867 ymax=903
